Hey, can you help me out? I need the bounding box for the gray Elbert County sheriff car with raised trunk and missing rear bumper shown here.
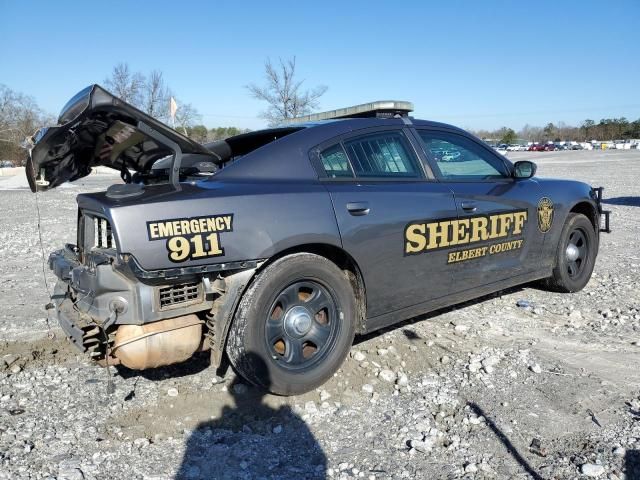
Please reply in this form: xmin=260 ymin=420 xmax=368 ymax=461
xmin=27 ymin=85 xmax=609 ymax=395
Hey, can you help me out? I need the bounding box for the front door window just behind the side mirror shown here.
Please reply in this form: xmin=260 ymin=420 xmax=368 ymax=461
xmin=418 ymin=130 xmax=509 ymax=180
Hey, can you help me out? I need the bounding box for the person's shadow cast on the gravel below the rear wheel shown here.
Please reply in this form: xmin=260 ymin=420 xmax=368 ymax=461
xmin=176 ymin=353 xmax=327 ymax=480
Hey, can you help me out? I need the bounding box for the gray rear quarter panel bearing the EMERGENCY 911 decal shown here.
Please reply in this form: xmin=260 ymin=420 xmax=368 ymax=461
xmin=92 ymin=182 xmax=342 ymax=271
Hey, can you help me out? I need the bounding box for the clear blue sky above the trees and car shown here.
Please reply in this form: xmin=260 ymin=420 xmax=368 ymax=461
xmin=0 ymin=0 xmax=640 ymax=129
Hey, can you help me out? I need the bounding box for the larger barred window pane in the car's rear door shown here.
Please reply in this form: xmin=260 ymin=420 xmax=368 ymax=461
xmin=344 ymin=132 xmax=421 ymax=178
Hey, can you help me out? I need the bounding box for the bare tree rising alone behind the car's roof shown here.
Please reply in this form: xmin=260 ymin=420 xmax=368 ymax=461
xmin=246 ymin=57 xmax=327 ymax=125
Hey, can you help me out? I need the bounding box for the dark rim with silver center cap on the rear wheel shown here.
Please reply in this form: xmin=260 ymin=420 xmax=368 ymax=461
xmin=265 ymin=280 xmax=340 ymax=370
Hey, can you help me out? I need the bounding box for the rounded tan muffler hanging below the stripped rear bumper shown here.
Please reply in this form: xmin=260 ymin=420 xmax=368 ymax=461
xmin=112 ymin=314 xmax=204 ymax=370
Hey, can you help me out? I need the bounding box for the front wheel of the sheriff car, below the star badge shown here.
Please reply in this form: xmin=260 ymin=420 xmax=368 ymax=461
xmin=545 ymin=213 xmax=598 ymax=293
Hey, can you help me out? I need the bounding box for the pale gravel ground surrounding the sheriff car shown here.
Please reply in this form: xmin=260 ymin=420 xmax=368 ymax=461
xmin=0 ymin=151 xmax=640 ymax=479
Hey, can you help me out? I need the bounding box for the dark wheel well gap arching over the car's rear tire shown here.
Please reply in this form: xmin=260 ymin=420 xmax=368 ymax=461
xmin=260 ymin=243 xmax=367 ymax=333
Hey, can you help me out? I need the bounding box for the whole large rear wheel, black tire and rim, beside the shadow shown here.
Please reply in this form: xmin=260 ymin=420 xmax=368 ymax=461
xmin=227 ymin=253 xmax=356 ymax=395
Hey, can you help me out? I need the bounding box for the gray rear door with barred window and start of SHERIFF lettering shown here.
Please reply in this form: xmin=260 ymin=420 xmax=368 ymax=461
xmin=311 ymin=127 xmax=457 ymax=323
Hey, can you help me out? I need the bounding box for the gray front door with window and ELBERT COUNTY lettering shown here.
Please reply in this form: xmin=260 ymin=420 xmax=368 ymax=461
xmin=416 ymin=128 xmax=544 ymax=292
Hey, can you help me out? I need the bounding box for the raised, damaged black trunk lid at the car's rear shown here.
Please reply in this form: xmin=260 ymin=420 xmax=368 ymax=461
xmin=26 ymin=85 xmax=219 ymax=192
